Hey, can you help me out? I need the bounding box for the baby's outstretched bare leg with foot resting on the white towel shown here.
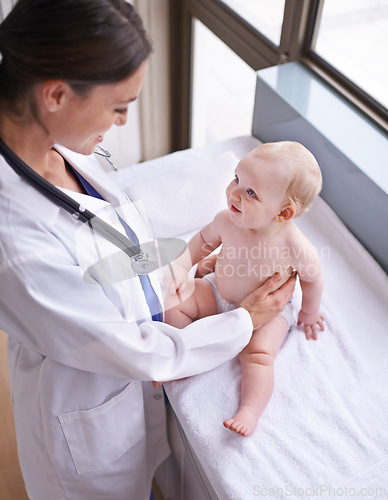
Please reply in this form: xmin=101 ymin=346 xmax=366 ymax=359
xmin=224 ymin=316 xmax=288 ymax=436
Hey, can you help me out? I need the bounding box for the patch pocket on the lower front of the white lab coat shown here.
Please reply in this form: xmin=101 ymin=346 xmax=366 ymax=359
xmin=58 ymin=382 xmax=145 ymax=474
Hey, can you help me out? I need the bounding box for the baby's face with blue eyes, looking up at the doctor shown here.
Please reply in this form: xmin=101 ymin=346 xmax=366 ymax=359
xmin=226 ymin=148 xmax=289 ymax=230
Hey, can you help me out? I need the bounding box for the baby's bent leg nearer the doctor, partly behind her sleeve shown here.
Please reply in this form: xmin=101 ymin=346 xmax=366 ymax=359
xmin=164 ymin=279 xmax=217 ymax=328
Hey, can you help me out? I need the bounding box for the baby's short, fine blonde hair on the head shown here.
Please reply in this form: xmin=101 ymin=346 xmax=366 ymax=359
xmin=257 ymin=141 xmax=322 ymax=217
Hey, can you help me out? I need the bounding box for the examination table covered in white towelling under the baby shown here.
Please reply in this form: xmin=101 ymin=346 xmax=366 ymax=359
xmin=112 ymin=136 xmax=388 ymax=500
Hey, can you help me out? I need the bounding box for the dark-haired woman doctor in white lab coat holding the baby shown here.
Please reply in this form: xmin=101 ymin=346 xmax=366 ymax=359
xmin=0 ymin=0 xmax=294 ymax=500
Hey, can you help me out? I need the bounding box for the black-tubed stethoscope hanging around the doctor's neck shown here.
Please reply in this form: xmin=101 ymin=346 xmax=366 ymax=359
xmin=0 ymin=139 xmax=186 ymax=275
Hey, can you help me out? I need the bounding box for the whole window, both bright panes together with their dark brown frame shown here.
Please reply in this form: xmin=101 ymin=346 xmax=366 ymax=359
xmin=170 ymin=0 xmax=388 ymax=150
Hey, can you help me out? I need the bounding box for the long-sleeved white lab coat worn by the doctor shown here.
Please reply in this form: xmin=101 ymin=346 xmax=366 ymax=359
xmin=0 ymin=148 xmax=252 ymax=500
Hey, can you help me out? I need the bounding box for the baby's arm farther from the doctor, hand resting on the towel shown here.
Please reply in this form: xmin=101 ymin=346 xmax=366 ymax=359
xmin=296 ymin=243 xmax=324 ymax=340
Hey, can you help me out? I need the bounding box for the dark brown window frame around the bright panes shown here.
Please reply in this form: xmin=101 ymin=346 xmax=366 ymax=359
xmin=169 ymin=0 xmax=388 ymax=151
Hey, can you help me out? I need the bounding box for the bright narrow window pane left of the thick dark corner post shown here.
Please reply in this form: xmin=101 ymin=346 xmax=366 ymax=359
xmin=191 ymin=20 xmax=256 ymax=147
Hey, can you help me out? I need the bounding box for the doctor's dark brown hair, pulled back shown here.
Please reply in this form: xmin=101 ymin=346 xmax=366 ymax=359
xmin=0 ymin=0 xmax=152 ymax=115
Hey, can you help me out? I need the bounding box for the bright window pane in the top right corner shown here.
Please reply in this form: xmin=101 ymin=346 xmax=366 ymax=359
xmin=312 ymin=0 xmax=388 ymax=108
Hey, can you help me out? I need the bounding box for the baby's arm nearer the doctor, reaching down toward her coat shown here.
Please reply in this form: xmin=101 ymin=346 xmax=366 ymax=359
xmin=164 ymin=212 xmax=225 ymax=295
